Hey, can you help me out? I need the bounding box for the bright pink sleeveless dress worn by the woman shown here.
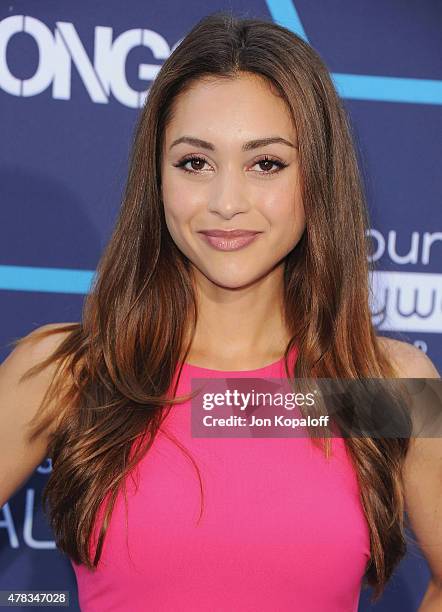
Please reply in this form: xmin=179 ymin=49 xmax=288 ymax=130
xmin=72 ymin=351 xmax=370 ymax=612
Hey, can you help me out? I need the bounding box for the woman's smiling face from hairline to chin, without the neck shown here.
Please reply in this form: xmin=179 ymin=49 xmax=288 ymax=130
xmin=161 ymin=73 xmax=305 ymax=289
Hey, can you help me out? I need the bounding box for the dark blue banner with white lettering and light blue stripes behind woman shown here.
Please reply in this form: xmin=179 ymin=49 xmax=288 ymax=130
xmin=0 ymin=0 xmax=442 ymax=612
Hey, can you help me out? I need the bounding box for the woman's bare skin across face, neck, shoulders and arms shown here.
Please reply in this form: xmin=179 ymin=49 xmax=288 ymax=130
xmin=0 ymin=74 xmax=442 ymax=612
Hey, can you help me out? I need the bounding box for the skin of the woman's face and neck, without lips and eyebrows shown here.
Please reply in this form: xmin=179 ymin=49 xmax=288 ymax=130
xmin=161 ymin=71 xmax=305 ymax=370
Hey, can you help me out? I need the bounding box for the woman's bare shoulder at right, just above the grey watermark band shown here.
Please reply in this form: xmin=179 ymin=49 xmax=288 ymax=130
xmin=378 ymin=336 xmax=440 ymax=378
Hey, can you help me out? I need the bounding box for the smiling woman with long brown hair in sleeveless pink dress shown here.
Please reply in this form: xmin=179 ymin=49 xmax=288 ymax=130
xmin=0 ymin=9 xmax=442 ymax=612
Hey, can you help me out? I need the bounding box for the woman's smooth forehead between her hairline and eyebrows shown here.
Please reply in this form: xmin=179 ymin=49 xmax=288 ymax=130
xmin=166 ymin=73 xmax=296 ymax=140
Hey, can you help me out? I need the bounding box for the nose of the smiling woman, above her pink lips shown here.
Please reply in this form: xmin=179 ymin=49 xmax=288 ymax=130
xmin=207 ymin=169 xmax=250 ymax=219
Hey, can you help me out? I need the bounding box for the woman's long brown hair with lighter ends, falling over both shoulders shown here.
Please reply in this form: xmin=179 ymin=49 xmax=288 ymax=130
xmin=14 ymin=12 xmax=409 ymax=599
